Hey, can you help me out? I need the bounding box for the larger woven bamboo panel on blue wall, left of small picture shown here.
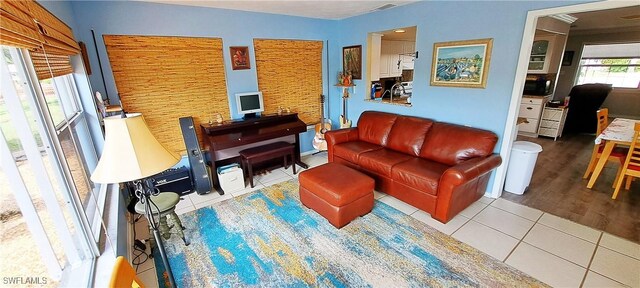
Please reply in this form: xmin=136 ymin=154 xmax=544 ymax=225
xmin=104 ymin=35 xmax=230 ymax=153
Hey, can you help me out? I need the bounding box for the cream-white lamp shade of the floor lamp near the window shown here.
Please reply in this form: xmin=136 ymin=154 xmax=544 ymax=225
xmin=91 ymin=113 xmax=180 ymax=183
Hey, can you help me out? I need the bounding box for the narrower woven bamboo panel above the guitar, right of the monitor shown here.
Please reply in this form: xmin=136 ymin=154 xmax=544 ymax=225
xmin=253 ymin=39 xmax=322 ymax=124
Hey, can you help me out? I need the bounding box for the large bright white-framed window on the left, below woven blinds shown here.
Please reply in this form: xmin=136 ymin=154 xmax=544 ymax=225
xmin=0 ymin=46 xmax=99 ymax=286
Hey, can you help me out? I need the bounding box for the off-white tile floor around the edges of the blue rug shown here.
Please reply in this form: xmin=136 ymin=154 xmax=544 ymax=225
xmin=136 ymin=154 xmax=640 ymax=287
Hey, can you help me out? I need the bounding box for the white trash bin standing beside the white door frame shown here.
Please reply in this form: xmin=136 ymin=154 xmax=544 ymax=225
xmin=504 ymin=141 xmax=542 ymax=195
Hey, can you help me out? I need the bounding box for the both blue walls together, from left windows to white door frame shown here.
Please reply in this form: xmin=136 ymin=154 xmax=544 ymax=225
xmin=65 ymin=1 xmax=596 ymax=160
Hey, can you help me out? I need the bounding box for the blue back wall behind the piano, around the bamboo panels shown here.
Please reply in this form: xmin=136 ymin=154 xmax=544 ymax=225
xmin=72 ymin=1 xmax=337 ymax=151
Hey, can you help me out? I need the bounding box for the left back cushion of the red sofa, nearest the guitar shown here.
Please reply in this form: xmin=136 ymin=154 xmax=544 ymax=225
xmin=358 ymin=111 xmax=398 ymax=146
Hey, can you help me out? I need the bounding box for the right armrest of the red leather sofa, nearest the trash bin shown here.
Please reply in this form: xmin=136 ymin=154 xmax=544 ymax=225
xmin=434 ymin=154 xmax=502 ymax=223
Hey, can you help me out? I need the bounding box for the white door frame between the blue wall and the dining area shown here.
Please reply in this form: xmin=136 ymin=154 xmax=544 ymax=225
xmin=489 ymin=0 xmax=638 ymax=198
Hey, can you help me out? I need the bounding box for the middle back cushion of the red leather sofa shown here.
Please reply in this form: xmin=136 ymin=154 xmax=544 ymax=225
xmin=386 ymin=116 xmax=433 ymax=156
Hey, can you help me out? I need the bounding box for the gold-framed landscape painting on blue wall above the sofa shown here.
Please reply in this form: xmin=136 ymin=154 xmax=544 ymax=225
xmin=431 ymin=38 xmax=493 ymax=88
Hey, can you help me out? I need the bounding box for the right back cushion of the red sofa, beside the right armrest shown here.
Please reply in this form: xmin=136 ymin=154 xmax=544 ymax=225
xmin=420 ymin=122 xmax=498 ymax=166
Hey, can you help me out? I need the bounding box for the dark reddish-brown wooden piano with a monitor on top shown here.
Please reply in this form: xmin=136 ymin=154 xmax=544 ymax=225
xmin=200 ymin=113 xmax=309 ymax=191
